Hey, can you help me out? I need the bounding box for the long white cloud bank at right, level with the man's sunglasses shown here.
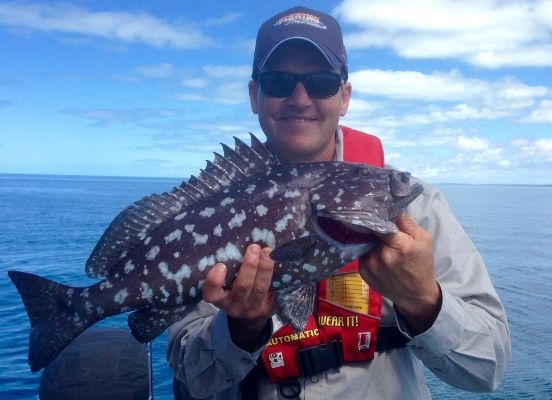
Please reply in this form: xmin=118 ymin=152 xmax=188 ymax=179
xmin=350 ymin=69 xmax=552 ymax=127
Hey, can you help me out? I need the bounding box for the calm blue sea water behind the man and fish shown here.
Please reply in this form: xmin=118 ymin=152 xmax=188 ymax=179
xmin=0 ymin=175 xmax=552 ymax=399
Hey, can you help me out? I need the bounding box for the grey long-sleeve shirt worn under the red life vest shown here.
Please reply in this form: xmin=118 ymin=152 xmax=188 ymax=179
xmin=168 ymin=132 xmax=511 ymax=400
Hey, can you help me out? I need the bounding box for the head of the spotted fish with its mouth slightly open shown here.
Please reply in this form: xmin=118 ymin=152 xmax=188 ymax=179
xmin=310 ymin=162 xmax=423 ymax=258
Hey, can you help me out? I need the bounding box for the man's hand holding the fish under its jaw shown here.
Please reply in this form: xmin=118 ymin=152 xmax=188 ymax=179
xmin=359 ymin=214 xmax=442 ymax=335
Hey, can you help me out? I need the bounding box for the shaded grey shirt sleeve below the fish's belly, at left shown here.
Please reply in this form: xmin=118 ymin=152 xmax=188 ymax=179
xmin=167 ymin=301 xmax=273 ymax=399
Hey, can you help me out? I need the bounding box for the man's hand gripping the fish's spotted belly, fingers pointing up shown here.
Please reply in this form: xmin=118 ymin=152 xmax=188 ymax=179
xmin=202 ymin=244 xmax=276 ymax=350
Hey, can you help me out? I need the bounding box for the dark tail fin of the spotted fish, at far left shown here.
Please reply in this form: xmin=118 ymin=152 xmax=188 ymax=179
xmin=8 ymin=271 xmax=90 ymax=372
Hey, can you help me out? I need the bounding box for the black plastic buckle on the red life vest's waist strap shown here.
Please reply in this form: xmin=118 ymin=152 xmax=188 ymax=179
xmin=297 ymin=340 xmax=343 ymax=376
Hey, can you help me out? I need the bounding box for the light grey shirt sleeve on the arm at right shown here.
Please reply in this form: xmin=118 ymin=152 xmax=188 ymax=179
xmin=397 ymin=180 xmax=511 ymax=392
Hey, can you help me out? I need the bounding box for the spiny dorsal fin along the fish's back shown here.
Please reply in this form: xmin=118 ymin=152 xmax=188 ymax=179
xmin=85 ymin=134 xmax=278 ymax=277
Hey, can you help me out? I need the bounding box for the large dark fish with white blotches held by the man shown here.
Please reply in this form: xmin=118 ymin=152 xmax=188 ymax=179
xmin=9 ymin=135 xmax=423 ymax=372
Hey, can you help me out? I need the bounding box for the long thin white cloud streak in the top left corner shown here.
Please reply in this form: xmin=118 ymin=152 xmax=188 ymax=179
xmin=0 ymin=2 xmax=213 ymax=48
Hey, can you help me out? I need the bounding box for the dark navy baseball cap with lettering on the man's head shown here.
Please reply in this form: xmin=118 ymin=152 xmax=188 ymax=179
xmin=251 ymin=7 xmax=348 ymax=81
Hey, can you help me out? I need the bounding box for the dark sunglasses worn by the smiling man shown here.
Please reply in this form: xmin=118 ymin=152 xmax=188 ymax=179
xmin=258 ymin=71 xmax=343 ymax=99
